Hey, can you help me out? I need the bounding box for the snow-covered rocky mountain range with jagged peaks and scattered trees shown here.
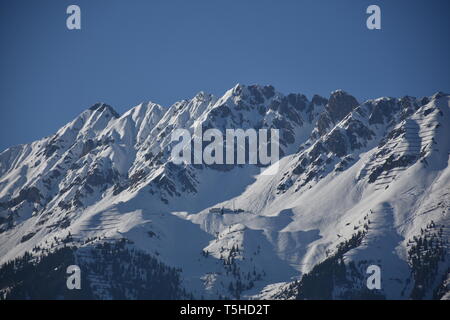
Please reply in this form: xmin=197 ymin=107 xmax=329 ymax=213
xmin=0 ymin=85 xmax=450 ymax=299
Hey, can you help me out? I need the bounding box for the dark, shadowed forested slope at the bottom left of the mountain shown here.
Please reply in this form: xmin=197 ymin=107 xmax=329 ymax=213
xmin=0 ymin=238 xmax=193 ymax=300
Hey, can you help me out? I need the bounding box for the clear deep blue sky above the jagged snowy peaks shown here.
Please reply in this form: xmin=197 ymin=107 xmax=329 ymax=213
xmin=0 ymin=0 xmax=450 ymax=150
